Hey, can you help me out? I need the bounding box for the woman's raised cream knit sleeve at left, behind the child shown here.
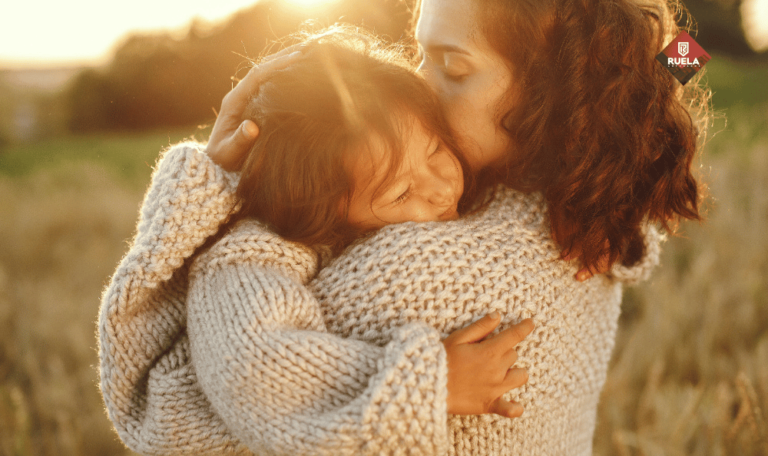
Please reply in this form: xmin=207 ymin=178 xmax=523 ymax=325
xmin=98 ymin=143 xmax=242 ymax=454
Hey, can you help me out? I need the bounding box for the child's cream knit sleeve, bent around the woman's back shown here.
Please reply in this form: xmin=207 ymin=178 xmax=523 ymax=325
xmin=187 ymin=221 xmax=448 ymax=455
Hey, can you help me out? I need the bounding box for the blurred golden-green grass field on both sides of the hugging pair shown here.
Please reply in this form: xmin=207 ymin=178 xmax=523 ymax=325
xmin=0 ymin=58 xmax=768 ymax=456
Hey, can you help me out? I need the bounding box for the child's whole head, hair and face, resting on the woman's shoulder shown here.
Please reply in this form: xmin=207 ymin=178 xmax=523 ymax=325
xmin=222 ymin=30 xmax=471 ymax=252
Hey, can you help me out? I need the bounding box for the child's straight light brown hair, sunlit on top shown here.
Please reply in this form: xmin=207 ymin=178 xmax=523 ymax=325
xmin=233 ymin=26 xmax=471 ymax=252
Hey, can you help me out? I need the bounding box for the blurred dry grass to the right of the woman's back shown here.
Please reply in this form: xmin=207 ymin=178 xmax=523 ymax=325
xmin=595 ymin=100 xmax=768 ymax=456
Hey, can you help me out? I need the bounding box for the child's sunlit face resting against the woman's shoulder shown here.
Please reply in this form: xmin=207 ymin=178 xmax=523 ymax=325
xmin=348 ymin=119 xmax=464 ymax=231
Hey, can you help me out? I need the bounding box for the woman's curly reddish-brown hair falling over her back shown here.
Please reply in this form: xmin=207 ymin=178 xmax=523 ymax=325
xmin=417 ymin=0 xmax=709 ymax=269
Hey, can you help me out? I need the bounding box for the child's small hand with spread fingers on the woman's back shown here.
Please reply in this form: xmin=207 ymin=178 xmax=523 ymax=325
xmin=443 ymin=312 xmax=533 ymax=418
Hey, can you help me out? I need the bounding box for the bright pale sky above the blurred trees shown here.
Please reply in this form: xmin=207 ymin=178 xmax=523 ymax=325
xmin=0 ymin=0 xmax=768 ymax=68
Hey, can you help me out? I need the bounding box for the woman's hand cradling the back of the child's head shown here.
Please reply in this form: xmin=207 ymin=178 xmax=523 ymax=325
xmin=205 ymin=46 xmax=301 ymax=171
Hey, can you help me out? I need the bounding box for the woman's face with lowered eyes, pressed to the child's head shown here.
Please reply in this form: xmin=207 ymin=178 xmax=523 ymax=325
xmin=416 ymin=0 xmax=515 ymax=170
